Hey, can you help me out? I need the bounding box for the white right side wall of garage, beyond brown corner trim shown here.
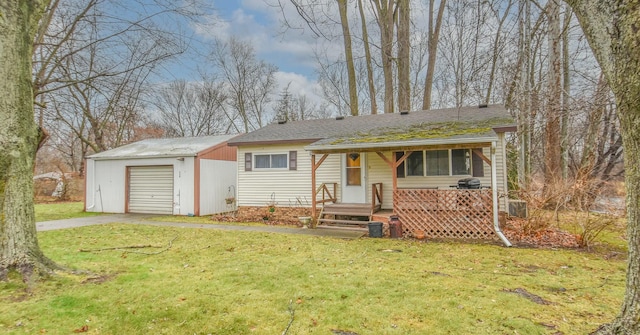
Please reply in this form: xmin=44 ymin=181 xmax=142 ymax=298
xmin=200 ymin=160 xmax=238 ymax=215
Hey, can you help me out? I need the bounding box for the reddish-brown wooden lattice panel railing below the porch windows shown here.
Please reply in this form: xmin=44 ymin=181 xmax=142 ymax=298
xmin=393 ymin=189 xmax=497 ymax=239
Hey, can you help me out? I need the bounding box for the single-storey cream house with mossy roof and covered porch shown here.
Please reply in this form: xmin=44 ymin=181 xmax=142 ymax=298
xmin=229 ymin=105 xmax=516 ymax=244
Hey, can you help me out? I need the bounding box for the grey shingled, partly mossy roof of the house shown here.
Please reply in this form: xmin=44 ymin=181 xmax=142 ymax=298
xmin=229 ymin=105 xmax=515 ymax=150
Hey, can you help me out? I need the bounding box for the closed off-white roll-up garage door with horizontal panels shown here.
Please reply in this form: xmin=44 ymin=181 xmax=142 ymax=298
xmin=129 ymin=166 xmax=173 ymax=215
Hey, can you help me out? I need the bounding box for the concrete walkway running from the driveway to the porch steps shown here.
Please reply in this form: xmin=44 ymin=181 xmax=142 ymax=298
xmin=36 ymin=214 xmax=365 ymax=239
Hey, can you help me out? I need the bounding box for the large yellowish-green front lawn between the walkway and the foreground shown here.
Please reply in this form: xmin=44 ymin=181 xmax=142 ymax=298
xmin=0 ymin=224 xmax=625 ymax=335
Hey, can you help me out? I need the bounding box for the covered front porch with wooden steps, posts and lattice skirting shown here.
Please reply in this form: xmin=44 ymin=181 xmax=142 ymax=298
xmin=311 ymin=142 xmax=511 ymax=246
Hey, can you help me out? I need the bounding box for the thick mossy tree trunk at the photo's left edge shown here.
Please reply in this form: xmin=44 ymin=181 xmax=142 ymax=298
xmin=0 ymin=0 xmax=55 ymax=281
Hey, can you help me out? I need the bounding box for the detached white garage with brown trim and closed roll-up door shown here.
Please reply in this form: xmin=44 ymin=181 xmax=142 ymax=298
xmin=85 ymin=135 xmax=238 ymax=216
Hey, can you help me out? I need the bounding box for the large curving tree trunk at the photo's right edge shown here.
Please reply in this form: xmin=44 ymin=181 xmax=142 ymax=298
xmin=567 ymin=0 xmax=640 ymax=334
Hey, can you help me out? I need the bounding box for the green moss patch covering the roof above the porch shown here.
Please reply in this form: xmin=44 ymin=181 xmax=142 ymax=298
xmin=331 ymin=118 xmax=513 ymax=145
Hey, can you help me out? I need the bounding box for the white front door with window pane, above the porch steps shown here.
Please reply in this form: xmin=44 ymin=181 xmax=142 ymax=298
xmin=341 ymin=152 xmax=367 ymax=204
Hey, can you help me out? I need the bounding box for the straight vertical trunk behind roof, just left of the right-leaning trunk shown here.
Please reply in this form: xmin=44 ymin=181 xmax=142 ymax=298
xmin=396 ymin=0 xmax=411 ymax=111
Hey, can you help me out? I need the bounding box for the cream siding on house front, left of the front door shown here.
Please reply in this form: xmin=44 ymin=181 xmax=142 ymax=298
xmin=237 ymin=145 xmax=340 ymax=207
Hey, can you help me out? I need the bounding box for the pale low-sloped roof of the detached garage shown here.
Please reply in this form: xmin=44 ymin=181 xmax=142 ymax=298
xmin=87 ymin=135 xmax=237 ymax=160
